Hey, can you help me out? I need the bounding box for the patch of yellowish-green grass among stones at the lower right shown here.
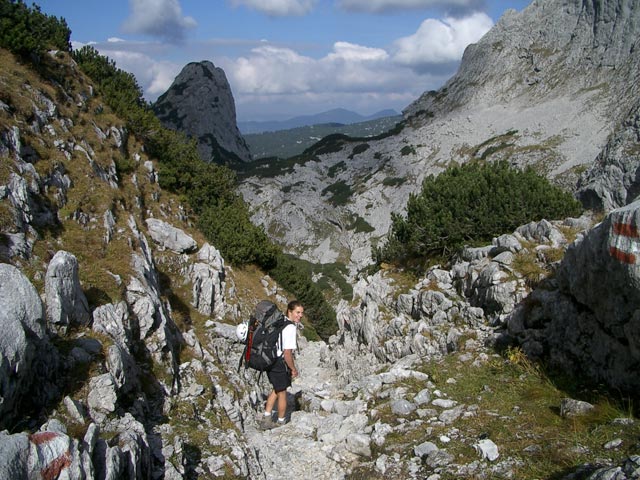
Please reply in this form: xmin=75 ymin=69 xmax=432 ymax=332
xmin=370 ymin=349 xmax=640 ymax=480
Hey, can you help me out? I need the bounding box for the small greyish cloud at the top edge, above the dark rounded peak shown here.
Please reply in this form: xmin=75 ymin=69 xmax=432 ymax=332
xmin=122 ymin=0 xmax=197 ymax=42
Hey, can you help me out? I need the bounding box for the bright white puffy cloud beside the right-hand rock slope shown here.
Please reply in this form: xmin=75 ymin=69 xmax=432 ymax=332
xmin=393 ymin=13 xmax=493 ymax=71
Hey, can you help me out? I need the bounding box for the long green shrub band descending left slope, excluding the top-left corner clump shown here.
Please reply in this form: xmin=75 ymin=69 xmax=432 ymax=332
xmin=73 ymin=47 xmax=335 ymax=338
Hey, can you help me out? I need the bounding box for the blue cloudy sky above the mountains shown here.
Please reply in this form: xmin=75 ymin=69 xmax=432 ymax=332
xmin=33 ymin=0 xmax=529 ymax=121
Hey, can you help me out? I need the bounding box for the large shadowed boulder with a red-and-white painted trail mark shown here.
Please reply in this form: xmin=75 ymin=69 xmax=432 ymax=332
xmin=507 ymin=202 xmax=640 ymax=392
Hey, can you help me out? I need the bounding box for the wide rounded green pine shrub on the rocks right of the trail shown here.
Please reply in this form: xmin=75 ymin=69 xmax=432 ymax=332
xmin=374 ymin=161 xmax=581 ymax=263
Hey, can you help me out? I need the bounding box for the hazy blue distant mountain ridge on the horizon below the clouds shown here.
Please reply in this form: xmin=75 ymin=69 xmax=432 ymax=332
xmin=238 ymin=108 xmax=399 ymax=134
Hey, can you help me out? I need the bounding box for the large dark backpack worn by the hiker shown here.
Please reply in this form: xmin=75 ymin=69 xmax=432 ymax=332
xmin=238 ymin=300 xmax=291 ymax=372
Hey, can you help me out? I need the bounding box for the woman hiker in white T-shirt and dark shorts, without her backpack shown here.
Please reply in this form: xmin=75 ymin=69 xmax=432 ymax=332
xmin=260 ymin=300 xmax=304 ymax=429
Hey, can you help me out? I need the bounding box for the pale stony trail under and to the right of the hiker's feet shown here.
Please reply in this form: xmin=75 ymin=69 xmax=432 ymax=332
xmin=238 ymin=332 xmax=498 ymax=480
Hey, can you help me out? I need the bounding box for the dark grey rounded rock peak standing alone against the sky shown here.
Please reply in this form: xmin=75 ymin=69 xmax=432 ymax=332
xmin=153 ymin=61 xmax=251 ymax=164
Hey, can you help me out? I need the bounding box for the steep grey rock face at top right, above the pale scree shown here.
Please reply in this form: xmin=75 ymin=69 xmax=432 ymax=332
xmin=404 ymin=0 xmax=640 ymax=122
